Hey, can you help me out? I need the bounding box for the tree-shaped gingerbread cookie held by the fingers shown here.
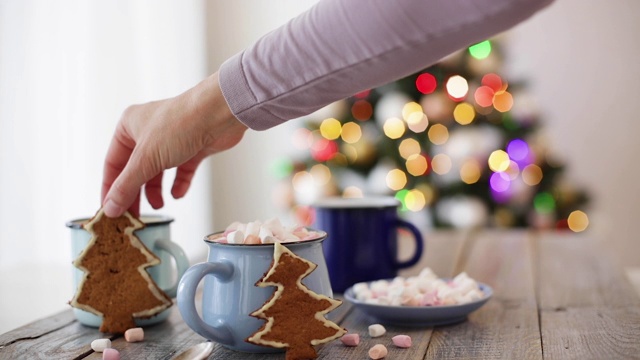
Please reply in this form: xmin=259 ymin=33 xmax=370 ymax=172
xmin=70 ymin=209 xmax=172 ymax=333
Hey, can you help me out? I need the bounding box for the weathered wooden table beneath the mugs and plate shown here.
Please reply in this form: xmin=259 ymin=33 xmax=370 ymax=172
xmin=0 ymin=231 xmax=640 ymax=360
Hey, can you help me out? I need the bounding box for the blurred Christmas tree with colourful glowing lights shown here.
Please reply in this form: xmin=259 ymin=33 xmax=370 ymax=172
xmin=290 ymin=40 xmax=588 ymax=231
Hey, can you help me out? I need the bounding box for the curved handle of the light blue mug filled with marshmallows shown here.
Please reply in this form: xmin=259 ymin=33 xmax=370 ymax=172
xmin=177 ymin=260 xmax=234 ymax=345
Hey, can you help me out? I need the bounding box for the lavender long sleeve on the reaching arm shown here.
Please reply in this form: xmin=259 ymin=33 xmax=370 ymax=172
xmin=219 ymin=0 xmax=552 ymax=130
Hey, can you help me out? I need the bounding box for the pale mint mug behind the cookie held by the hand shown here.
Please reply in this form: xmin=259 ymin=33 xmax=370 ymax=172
xmin=66 ymin=215 xmax=189 ymax=327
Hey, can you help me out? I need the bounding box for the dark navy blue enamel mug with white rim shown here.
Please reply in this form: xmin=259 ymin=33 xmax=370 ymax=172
xmin=313 ymin=196 xmax=424 ymax=292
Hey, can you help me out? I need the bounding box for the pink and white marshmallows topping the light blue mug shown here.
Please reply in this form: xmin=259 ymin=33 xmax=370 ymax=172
xmin=212 ymin=218 xmax=320 ymax=245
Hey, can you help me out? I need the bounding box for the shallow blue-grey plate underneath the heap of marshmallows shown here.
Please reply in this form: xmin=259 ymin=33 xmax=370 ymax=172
xmin=344 ymin=283 xmax=493 ymax=327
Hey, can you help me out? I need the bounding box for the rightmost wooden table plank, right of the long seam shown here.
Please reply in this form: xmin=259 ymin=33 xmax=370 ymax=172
xmin=537 ymin=233 xmax=640 ymax=359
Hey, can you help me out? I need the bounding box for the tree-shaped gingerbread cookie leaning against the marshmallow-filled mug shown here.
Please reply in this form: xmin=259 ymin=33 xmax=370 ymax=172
xmin=247 ymin=243 xmax=346 ymax=360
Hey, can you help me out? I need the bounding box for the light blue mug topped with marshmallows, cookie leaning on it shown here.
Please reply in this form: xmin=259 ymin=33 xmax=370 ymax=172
xmin=177 ymin=232 xmax=333 ymax=353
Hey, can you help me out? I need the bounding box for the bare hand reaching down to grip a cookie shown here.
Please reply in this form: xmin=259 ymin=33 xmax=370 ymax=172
xmin=102 ymin=73 xmax=247 ymax=217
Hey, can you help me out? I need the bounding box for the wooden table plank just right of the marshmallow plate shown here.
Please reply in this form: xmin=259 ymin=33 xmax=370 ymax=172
xmin=427 ymin=231 xmax=542 ymax=359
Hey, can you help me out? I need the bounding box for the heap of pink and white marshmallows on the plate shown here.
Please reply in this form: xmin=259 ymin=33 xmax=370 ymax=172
xmin=353 ymin=268 xmax=484 ymax=306
